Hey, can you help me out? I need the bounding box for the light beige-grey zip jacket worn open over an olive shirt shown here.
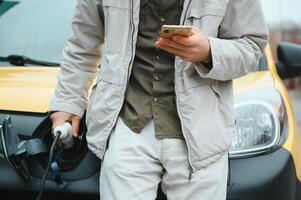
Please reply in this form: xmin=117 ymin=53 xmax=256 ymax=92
xmin=50 ymin=0 xmax=268 ymax=171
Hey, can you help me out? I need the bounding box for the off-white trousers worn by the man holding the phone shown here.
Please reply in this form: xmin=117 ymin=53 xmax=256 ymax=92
xmin=100 ymin=118 xmax=228 ymax=200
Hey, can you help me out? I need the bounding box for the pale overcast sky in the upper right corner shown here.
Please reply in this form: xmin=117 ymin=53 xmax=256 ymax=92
xmin=261 ymin=0 xmax=301 ymax=28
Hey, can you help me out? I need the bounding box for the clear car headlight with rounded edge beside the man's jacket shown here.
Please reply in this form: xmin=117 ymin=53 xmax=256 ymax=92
xmin=230 ymin=90 xmax=284 ymax=157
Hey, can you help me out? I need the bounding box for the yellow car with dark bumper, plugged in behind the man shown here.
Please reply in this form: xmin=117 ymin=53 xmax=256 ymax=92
xmin=0 ymin=0 xmax=301 ymax=200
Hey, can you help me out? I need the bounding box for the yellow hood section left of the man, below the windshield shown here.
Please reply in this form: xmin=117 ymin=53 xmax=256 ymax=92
xmin=0 ymin=67 xmax=60 ymax=113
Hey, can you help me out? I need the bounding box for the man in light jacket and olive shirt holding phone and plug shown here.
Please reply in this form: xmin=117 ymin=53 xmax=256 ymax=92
xmin=50 ymin=0 xmax=268 ymax=200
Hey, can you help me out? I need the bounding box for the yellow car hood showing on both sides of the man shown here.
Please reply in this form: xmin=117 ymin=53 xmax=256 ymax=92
xmin=0 ymin=67 xmax=274 ymax=113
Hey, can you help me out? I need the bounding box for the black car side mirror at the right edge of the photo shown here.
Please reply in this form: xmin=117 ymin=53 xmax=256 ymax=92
xmin=276 ymin=42 xmax=301 ymax=79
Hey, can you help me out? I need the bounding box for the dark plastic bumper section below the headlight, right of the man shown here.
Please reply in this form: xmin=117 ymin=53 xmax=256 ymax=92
xmin=227 ymin=148 xmax=301 ymax=200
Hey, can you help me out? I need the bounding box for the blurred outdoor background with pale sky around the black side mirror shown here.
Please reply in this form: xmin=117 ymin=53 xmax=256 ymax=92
xmin=261 ymin=0 xmax=301 ymax=133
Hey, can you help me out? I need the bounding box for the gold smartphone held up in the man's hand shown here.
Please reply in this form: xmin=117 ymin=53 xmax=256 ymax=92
xmin=160 ymin=25 xmax=192 ymax=38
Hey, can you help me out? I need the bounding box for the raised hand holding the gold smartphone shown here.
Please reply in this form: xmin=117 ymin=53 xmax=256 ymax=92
xmin=156 ymin=27 xmax=211 ymax=63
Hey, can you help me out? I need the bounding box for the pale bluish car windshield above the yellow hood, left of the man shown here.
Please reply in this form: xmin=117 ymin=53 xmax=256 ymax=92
xmin=0 ymin=0 xmax=267 ymax=71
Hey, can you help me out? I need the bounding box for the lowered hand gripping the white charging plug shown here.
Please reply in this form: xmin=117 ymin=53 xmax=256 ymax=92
xmin=50 ymin=111 xmax=81 ymax=137
